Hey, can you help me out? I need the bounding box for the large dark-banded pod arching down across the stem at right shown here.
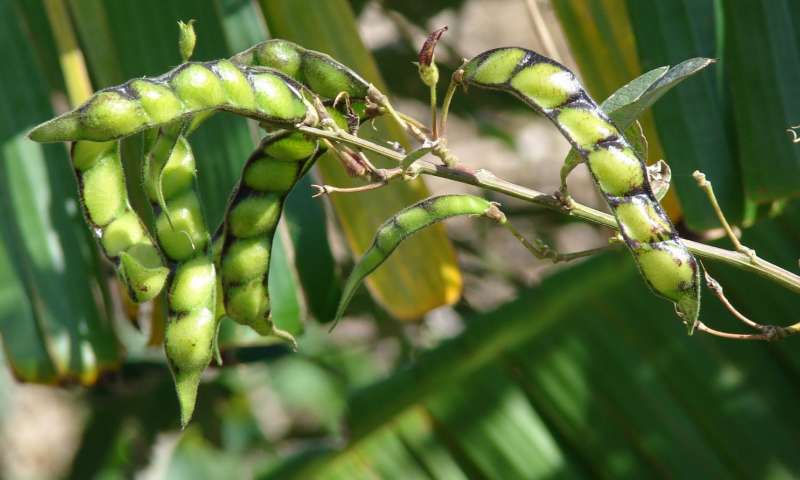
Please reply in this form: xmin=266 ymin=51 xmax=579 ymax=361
xmin=462 ymin=48 xmax=700 ymax=328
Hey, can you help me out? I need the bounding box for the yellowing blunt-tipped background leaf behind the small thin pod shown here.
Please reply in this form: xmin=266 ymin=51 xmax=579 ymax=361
xmin=260 ymin=0 xmax=461 ymax=320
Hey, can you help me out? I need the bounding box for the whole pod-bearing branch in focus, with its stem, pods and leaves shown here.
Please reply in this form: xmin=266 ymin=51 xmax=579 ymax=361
xmin=25 ymin=15 xmax=800 ymax=425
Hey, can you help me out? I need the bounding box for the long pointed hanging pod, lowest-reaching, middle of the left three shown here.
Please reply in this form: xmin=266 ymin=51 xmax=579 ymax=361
xmin=144 ymin=123 xmax=219 ymax=425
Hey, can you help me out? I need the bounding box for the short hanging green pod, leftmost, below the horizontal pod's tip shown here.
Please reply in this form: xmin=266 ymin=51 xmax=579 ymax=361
xmin=70 ymin=142 xmax=169 ymax=302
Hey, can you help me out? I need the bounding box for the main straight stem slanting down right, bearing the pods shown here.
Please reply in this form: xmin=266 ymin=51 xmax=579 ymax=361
xmin=298 ymin=125 xmax=800 ymax=294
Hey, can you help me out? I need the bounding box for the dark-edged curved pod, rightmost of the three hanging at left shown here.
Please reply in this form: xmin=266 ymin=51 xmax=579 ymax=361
xmin=214 ymin=131 xmax=320 ymax=341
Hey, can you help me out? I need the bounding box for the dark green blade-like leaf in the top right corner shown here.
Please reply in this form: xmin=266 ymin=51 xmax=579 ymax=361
xmin=720 ymin=0 xmax=800 ymax=202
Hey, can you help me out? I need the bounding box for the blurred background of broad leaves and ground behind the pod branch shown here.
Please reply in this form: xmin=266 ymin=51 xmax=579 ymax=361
xmin=0 ymin=0 xmax=800 ymax=479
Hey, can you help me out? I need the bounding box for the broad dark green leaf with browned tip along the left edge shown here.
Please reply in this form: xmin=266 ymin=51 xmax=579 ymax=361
xmin=0 ymin=2 xmax=121 ymax=384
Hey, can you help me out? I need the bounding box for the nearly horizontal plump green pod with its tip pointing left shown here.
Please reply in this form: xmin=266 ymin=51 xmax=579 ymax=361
xmin=29 ymin=60 xmax=316 ymax=142
